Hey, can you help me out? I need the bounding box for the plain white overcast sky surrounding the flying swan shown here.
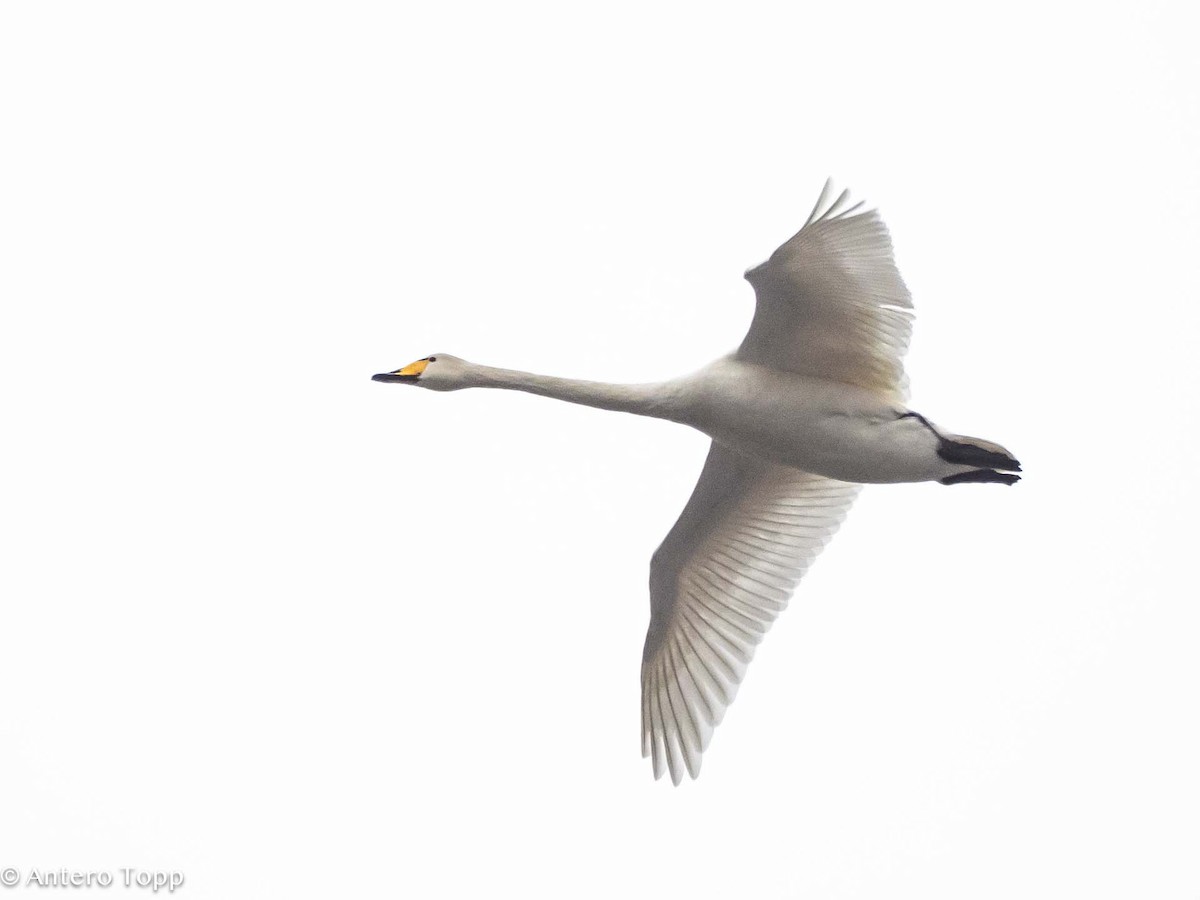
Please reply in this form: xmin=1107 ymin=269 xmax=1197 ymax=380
xmin=0 ymin=1 xmax=1200 ymax=900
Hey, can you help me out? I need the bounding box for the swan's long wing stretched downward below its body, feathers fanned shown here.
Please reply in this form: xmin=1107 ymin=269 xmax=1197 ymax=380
xmin=642 ymin=443 xmax=862 ymax=785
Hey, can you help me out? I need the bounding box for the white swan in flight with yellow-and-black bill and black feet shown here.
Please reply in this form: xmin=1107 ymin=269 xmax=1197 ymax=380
xmin=373 ymin=181 xmax=1021 ymax=785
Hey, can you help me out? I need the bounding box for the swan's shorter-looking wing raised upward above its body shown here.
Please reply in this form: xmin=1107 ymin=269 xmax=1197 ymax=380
xmin=737 ymin=181 xmax=912 ymax=401
